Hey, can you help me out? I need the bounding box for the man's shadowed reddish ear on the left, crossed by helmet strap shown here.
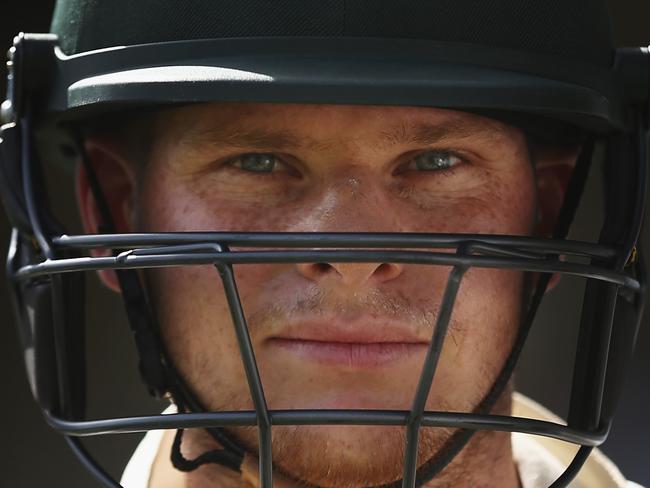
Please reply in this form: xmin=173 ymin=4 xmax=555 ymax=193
xmin=77 ymin=137 xmax=136 ymax=292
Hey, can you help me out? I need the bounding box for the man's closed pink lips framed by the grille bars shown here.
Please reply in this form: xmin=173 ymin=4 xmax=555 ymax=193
xmin=267 ymin=318 xmax=430 ymax=368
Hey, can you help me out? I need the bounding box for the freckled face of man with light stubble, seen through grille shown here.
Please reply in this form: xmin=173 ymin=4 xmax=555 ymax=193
xmin=129 ymin=104 xmax=536 ymax=486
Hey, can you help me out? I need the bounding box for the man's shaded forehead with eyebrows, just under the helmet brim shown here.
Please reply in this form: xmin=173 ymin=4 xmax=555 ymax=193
xmin=155 ymin=103 xmax=521 ymax=149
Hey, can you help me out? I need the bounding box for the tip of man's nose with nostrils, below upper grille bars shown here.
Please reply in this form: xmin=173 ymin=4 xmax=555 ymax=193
xmin=297 ymin=263 xmax=402 ymax=288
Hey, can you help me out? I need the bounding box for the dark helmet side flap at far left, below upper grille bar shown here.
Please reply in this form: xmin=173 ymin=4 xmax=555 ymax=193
xmin=7 ymin=230 xmax=86 ymax=419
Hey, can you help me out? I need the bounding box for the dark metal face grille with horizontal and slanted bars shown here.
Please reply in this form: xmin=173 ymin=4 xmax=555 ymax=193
xmin=16 ymin=233 xmax=640 ymax=488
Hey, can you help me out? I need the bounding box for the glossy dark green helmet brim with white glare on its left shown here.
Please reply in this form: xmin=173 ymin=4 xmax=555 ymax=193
xmin=39 ymin=38 xmax=624 ymax=132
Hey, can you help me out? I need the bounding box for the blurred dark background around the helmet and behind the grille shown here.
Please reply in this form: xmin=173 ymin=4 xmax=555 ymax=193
xmin=0 ymin=0 xmax=650 ymax=488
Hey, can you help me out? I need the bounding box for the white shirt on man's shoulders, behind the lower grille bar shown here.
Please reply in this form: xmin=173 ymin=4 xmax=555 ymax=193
xmin=121 ymin=393 xmax=642 ymax=488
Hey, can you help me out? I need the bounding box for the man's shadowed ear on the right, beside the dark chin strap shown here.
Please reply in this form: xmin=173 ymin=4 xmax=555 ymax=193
xmin=532 ymin=146 xmax=581 ymax=290
